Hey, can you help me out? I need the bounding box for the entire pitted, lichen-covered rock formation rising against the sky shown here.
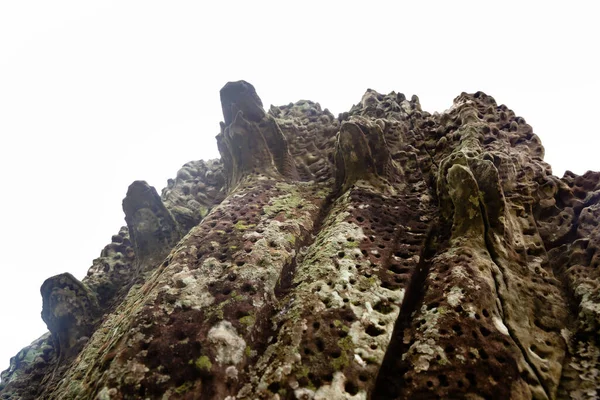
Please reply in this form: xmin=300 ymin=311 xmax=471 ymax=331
xmin=0 ymin=82 xmax=600 ymax=400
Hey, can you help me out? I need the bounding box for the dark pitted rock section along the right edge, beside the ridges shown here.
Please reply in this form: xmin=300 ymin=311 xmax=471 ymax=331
xmin=536 ymin=171 xmax=600 ymax=398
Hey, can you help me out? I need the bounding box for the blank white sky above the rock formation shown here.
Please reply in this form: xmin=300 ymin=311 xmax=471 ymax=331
xmin=0 ymin=0 xmax=600 ymax=370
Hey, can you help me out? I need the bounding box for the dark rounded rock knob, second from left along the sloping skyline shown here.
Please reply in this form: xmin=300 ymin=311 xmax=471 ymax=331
xmin=123 ymin=181 xmax=181 ymax=273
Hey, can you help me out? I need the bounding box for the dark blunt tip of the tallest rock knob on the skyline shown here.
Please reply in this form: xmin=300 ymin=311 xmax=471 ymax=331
xmin=221 ymin=81 xmax=265 ymax=126
